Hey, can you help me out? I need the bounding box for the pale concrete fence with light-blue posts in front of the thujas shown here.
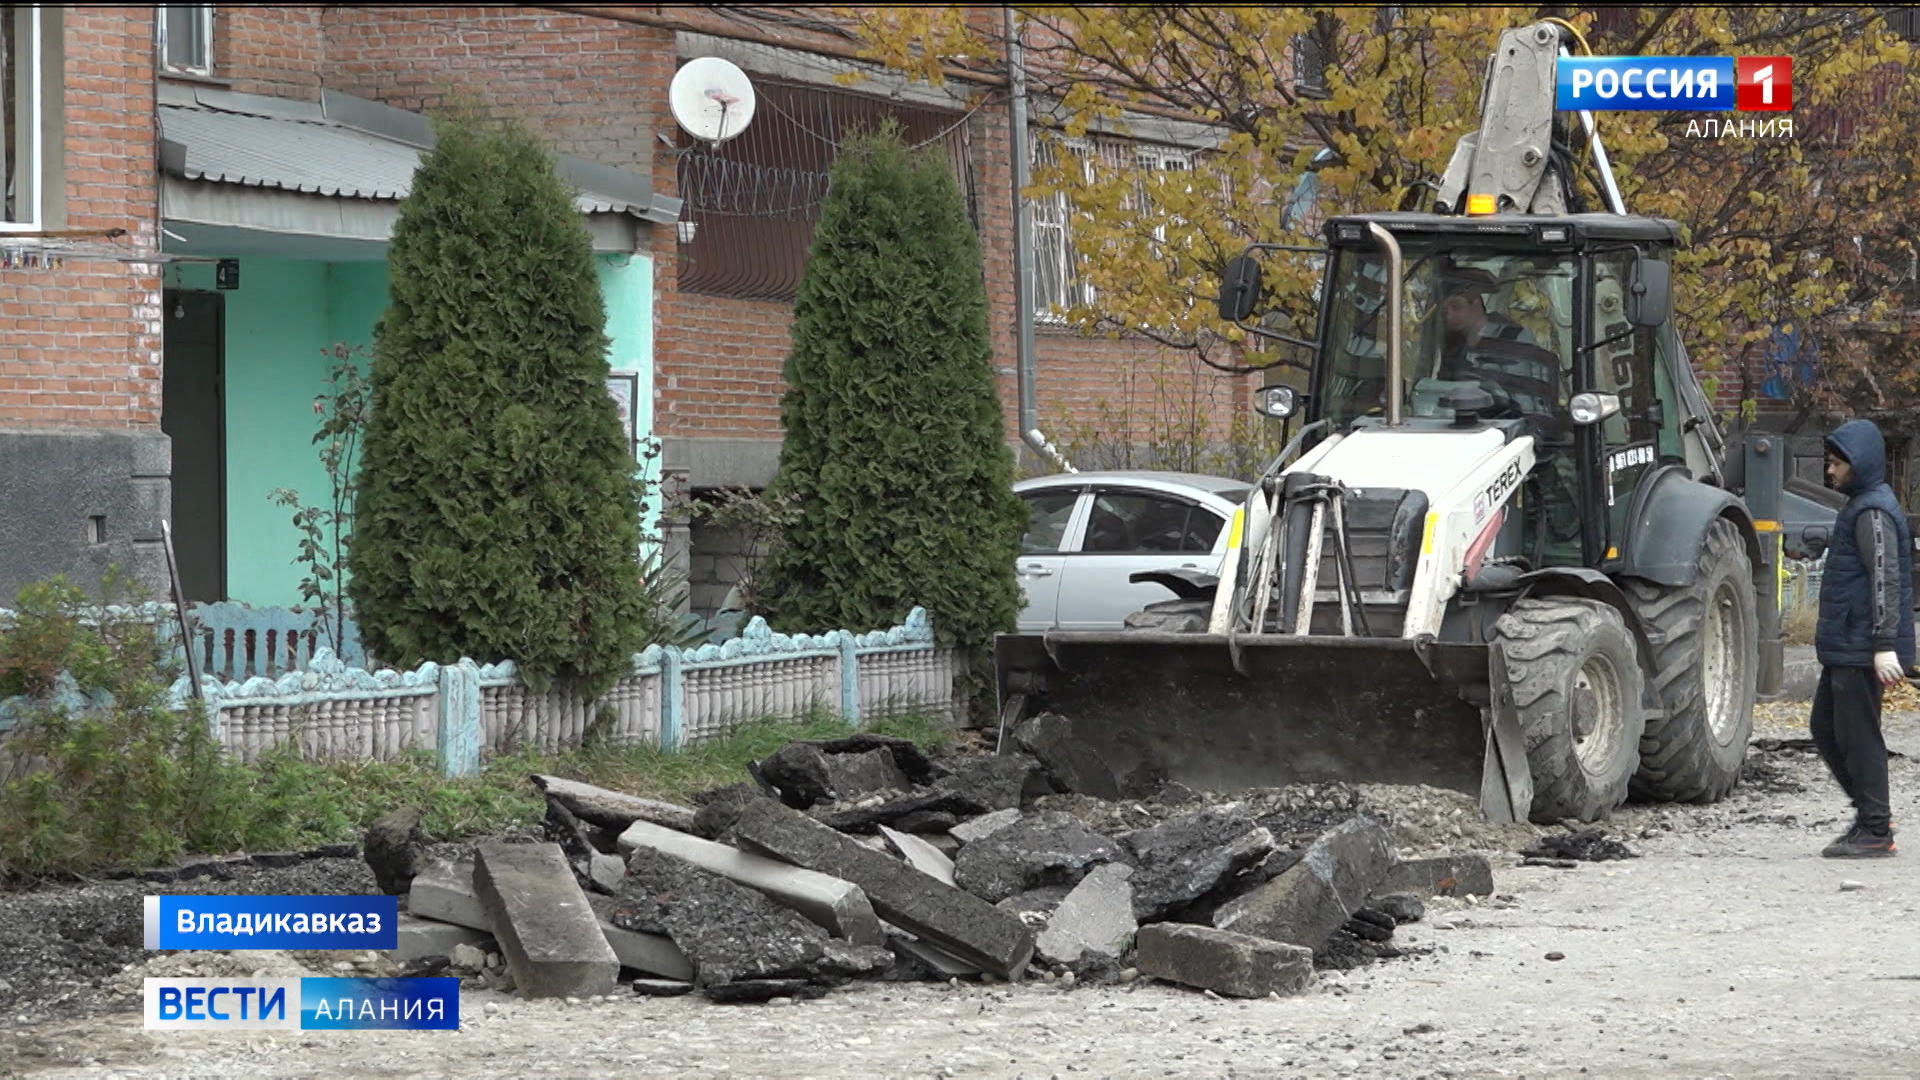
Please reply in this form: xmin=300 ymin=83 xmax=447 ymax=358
xmin=173 ymin=607 xmax=964 ymax=776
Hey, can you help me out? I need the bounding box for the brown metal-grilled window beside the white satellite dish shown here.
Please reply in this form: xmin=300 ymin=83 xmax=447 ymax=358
xmin=678 ymin=75 xmax=979 ymax=302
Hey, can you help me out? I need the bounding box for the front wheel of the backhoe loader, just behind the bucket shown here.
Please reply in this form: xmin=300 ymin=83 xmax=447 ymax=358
xmin=1494 ymin=598 xmax=1647 ymax=824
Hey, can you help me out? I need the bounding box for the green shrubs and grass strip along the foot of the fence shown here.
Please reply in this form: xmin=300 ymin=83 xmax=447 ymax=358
xmin=0 ymin=578 xmax=952 ymax=882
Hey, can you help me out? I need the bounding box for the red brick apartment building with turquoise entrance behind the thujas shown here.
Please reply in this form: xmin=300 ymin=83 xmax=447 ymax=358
xmin=0 ymin=4 xmax=1250 ymax=609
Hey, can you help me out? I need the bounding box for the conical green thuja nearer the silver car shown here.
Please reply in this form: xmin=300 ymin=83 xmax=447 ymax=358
xmin=768 ymin=127 xmax=1025 ymax=646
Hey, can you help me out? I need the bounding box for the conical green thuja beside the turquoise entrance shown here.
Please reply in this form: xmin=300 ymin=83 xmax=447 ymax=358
xmin=349 ymin=121 xmax=662 ymax=692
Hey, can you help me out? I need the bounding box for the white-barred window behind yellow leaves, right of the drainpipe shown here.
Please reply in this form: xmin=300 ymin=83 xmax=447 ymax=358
xmin=1031 ymin=138 xmax=1192 ymax=323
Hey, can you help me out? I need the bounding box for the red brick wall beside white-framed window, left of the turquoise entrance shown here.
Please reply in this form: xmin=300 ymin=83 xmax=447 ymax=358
xmin=0 ymin=8 xmax=161 ymax=429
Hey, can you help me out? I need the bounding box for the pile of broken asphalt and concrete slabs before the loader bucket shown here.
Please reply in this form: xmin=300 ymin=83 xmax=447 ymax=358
xmin=365 ymin=717 xmax=1492 ymax=1001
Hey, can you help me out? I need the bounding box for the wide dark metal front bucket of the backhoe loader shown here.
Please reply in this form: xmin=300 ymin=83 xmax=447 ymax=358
xmin=995 ymin=630 xmax=1532 ymax=821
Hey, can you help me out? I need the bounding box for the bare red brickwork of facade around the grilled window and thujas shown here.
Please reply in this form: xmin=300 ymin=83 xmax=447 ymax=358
xmin=309 ymin=8 xmax=1248 ymax=463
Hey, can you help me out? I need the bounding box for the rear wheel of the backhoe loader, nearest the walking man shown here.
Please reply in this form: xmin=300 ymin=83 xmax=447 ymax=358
xmin=1622 ymin=519 xmax=1761 ymax=803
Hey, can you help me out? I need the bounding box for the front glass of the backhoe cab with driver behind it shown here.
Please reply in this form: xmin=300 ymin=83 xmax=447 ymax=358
xmin=1321 ymin=236 xmax=1574 ymax=430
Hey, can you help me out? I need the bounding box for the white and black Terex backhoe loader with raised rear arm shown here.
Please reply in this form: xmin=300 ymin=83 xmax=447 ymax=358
xmin=995 ymin=19 xmax=1786 ymax=822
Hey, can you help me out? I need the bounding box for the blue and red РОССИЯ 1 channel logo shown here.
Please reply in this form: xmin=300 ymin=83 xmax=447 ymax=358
xmin=1553 ymin=56 xmax=1793 ymax=111
